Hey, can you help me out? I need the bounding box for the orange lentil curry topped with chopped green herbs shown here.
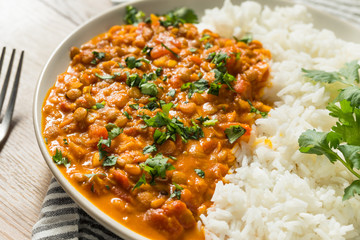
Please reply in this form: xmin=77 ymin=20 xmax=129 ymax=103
xmin=42 ymin=7 xmax=270 ymax=239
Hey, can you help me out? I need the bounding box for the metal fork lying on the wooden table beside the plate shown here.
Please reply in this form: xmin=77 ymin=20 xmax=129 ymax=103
xmin=0 ymin=47 xmax=24 ymax=145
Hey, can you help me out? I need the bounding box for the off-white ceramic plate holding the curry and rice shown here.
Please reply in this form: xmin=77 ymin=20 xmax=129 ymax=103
xmin=33 ymin=0 xmax=360 ymax=240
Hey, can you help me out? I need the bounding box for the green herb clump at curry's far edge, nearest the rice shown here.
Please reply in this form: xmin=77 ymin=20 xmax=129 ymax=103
xmin=160 ymin=7 xmax=198 ymax=27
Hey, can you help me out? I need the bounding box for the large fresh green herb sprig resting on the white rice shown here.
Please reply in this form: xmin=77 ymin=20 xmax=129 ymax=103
xmin=298 ymin=61 xmax=360 ymax=200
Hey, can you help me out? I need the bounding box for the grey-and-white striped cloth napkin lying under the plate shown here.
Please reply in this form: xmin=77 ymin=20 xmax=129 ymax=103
xmin=32 ymin=0 xmax=360 ymax=240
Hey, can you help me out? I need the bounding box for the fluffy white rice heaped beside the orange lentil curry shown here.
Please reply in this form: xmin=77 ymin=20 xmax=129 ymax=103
xmin=201 ymin=0 xmax=360 ymax=240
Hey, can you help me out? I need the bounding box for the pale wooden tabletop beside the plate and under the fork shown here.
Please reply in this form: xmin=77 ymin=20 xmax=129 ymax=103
xmin=0 ymin=0 xmax=112 ymax=240
